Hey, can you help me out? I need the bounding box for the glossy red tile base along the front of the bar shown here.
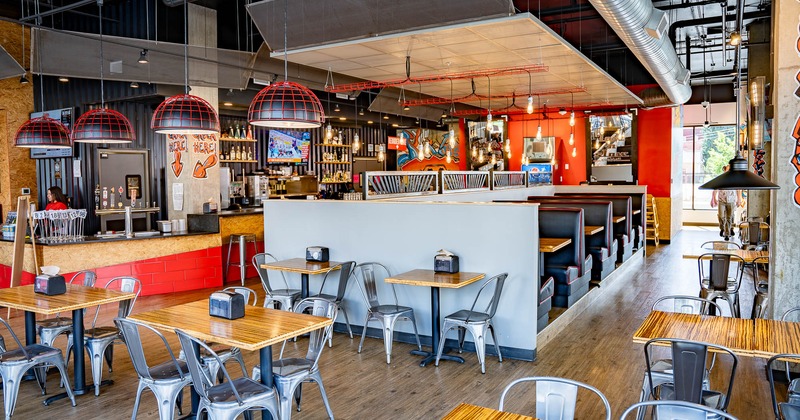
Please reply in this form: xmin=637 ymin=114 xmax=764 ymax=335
xmin=0 ymin=244 xmax=228 ymax=296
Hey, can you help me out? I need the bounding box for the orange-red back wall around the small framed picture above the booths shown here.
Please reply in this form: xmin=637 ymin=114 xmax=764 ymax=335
xmin=508 ymin=113 xmax=586 ymax=185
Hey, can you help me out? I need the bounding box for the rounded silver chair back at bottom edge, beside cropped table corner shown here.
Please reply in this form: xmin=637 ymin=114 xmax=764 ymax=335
xmin=499 ymin=376 xmax=611 ymax=420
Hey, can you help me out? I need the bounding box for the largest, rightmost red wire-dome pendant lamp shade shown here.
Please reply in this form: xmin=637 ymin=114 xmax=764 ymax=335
xmin=247 ymin=81 xmax=325 ymax=128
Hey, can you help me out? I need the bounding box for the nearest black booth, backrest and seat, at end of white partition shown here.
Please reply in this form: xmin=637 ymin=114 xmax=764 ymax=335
xmin=539 ymin=207 xmax=592 ymax=308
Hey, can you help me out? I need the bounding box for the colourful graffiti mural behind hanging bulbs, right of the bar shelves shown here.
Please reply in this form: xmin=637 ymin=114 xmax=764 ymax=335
xmin=397 ymin=128 xmax=460 ymax=171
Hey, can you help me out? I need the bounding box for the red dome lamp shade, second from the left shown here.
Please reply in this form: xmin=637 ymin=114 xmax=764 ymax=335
xmin=72 ymin=108 xmax=136 ymax=143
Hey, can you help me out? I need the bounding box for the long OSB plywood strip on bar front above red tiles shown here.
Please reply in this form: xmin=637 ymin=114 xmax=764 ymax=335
xmin=36 ymin=233 xmax=221 ymax=273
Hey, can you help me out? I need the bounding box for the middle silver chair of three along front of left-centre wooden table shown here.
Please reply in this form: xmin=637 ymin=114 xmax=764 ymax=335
xmin=175 ymin=330 xmax=279 ymax=420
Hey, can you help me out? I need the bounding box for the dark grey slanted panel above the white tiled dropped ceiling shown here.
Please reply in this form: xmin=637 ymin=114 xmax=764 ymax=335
xmin=247 ymin=0 xmax=514 ymax=51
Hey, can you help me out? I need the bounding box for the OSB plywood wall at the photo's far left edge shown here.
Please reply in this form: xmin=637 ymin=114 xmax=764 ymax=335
xmin=0 ymin=22 xmax=37 ymax=216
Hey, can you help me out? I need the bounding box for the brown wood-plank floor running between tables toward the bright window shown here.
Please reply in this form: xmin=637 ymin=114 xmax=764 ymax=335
xmin=4 ymin=228 xmax=771 ymax=420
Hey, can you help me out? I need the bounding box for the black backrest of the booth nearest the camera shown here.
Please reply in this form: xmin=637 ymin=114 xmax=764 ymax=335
xmin=539 ymin=207 xmax=586 ymax=274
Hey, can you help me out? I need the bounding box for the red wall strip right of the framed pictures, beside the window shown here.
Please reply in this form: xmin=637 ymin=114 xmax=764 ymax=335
xmin=636 ymin=108 xmax=672 ymax=197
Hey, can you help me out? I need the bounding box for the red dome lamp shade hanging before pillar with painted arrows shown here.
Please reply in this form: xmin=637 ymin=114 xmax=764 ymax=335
xmin=150 ymin=94 xmax=219 ymax=134
